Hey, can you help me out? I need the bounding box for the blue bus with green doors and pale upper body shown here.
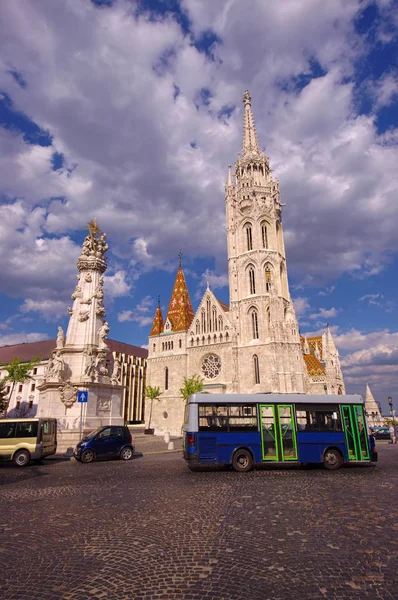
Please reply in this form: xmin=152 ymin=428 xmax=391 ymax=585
xmin=183 ymin=394 xmax=377 ymax=472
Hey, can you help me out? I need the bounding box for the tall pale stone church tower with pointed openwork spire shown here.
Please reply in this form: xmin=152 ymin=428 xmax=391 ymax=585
xmin=225 ymin=91 xmax=306 ymax=393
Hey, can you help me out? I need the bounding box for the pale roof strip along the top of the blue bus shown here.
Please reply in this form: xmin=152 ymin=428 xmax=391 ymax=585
xmin=188 ymin=394 xmax=364 ymax=404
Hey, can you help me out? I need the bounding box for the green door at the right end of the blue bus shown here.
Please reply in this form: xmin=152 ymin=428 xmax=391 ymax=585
xmin=341 ymin=404 xmax=370 ymax=461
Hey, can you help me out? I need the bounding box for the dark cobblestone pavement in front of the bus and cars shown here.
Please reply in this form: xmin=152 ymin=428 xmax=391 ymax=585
xmin=0 ymin=444 xmax=398 ymax=600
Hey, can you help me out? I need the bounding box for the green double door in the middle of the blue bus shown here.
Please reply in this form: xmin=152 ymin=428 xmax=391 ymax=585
xmin=260 ymin=404 xmax=298 ymax=462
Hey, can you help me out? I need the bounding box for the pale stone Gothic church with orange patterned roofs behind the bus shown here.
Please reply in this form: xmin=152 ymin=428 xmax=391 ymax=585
xmin=146 ymin=91 xmax=345 ymax=433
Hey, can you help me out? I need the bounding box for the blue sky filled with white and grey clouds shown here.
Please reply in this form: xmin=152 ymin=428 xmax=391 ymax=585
xmin=0 ymin=0 xmax=398 ymax=413
